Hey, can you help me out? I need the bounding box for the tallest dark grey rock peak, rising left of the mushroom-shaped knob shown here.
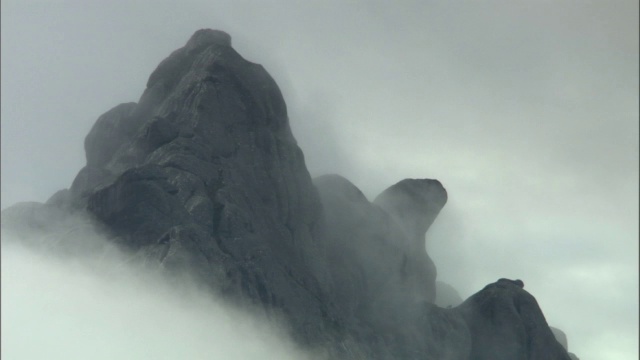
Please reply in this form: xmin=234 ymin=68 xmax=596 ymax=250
xmin=70 ymin=30 xmax=333 ymax=340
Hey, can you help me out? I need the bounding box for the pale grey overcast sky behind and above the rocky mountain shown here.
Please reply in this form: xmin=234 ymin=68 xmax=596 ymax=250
xmin=1 ymin=0 xmax=639 ymax=360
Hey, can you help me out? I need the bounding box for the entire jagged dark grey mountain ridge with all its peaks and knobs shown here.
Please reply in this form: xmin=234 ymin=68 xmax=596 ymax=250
xmin=2 ymin=30 xmax=568 ymax=360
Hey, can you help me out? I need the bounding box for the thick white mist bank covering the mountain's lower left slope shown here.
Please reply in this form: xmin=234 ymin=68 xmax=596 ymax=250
xmin=1 ymin=226 xmax=320 ymax=360
